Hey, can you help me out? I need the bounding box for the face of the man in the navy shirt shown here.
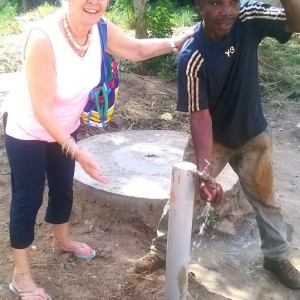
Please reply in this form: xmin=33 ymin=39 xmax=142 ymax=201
xmin=198 ymin=0 xmax=240 ymax=42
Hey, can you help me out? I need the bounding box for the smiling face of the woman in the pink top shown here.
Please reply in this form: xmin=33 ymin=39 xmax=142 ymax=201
xmin=68 ymin=0 xmax=109 ymax=26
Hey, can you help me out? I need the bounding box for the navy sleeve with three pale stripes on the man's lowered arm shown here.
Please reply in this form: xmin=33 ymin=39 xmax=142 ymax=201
xmin=177 ymin=50 xmax=208 ymax=113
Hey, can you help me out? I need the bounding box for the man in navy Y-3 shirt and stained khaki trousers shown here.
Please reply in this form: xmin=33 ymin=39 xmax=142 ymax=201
xmin=135 ymin=0 xmax=300 ymax=289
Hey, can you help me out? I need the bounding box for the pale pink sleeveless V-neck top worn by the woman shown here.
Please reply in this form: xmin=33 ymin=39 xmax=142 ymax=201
xmin=5 ymin=16 xmax=101 ymax=142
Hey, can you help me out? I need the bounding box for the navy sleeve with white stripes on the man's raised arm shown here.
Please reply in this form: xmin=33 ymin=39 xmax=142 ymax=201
xmin=239 ymin=1 xmax=291 ymax=43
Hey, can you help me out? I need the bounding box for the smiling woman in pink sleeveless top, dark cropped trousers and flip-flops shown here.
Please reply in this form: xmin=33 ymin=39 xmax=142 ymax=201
xmin=1 ymin=0 xmax=195 ymax=300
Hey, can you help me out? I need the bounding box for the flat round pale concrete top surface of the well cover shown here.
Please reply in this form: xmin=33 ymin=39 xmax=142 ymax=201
xmin=75 ymin=130 xmax=188 ymax=199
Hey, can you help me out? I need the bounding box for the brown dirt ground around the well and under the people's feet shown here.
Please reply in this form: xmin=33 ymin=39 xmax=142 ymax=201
xmin=0 ymin=74 xmax=300 ymax=300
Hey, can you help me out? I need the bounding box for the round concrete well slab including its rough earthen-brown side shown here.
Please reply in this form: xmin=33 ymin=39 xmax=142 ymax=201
xmin=74 ymin=130 xmax=246 ymax=229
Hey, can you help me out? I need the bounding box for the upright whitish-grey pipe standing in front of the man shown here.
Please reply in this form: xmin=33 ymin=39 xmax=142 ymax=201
xmin=164 ymin=161 xmax=196 ymax=300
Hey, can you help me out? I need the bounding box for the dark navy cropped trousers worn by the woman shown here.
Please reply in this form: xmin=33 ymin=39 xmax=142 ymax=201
xmin=5 ymin=133 xmax=76 ymax=249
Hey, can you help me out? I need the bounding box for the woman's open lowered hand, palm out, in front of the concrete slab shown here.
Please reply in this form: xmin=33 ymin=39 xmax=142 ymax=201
xmin=76 ymin=148 xmax=108 ymax=184
